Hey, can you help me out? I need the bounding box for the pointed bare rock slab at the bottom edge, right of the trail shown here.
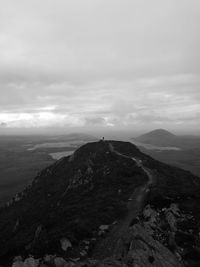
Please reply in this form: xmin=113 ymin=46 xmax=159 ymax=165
xmin=81 ymin=223 xmax=183 ymax=267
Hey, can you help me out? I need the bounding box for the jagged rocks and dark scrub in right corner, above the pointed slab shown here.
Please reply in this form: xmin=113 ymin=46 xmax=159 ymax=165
xmin=140 ymin=203 xmax=200 ymax=267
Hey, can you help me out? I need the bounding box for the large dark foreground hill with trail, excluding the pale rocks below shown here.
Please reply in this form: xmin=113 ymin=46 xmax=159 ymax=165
xmin=0 ymin=141 xmax=200 ymax=263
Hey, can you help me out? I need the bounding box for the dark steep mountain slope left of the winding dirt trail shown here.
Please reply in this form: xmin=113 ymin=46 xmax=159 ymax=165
xmin=0 ymin=142 xmax=147 ymax=264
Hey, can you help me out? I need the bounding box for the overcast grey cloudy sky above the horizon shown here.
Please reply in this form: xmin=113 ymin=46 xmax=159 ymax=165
xmin=0 ymin=0 xmax=200 ymax=136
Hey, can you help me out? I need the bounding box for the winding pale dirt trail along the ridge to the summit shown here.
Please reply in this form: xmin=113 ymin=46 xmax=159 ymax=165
xmin=92 ymin=144 xmax=153 ymax=259
